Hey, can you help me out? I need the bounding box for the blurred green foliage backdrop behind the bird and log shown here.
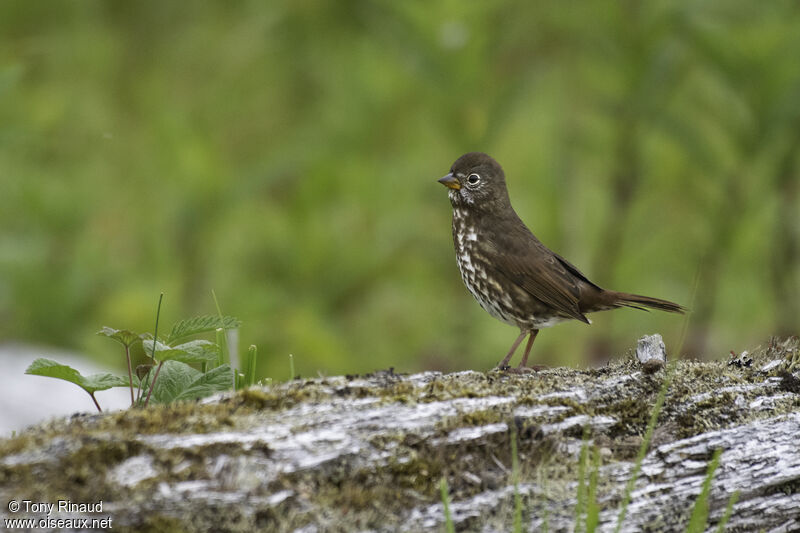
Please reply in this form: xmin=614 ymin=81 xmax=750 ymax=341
xmin=0 ymin=0 xmax=800 ymax=379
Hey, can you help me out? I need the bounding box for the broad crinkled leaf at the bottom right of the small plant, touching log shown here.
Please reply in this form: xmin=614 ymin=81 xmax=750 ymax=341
xmin=149 ymin=361 xmax=233 ymax=404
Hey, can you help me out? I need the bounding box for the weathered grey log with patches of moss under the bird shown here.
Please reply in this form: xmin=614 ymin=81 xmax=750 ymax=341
xmin=0 ymin=338 xmax=800 ymax=531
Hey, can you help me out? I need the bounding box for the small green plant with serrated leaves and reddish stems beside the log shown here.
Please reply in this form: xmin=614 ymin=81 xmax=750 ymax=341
xmin=25 ymin=293 xmax=244 ymax=412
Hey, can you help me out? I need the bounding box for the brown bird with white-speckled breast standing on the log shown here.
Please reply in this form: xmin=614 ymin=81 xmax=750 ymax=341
xmin=438 ymin=152 xmax=686 ymax=371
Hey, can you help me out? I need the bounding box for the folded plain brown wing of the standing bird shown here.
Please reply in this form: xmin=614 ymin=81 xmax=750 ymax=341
xmin=484 ymin=222 xmax=591 ymax=324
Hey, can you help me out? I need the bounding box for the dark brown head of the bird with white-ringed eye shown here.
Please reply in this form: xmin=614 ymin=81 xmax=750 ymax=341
xmin=439 ymin=152 xmax=510 ymax=210
